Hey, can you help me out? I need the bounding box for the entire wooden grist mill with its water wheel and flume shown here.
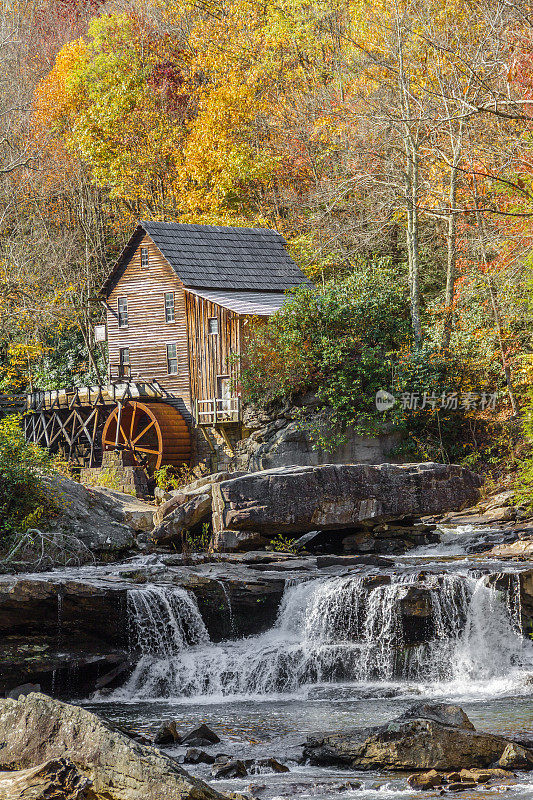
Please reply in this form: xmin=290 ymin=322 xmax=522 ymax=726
xmin=24 ymin=222 xmax=309 ymax=475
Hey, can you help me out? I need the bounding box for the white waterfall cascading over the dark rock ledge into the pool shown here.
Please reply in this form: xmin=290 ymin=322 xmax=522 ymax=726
xmin=110 ymin=574 xmax=533 ymax=699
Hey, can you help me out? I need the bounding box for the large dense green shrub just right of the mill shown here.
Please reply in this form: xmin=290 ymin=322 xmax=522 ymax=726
xmin=241 ymin=265 xmax=410 ymax=448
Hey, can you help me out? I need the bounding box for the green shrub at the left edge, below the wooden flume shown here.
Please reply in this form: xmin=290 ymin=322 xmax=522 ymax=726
xmin=0 ymin=415 xmax=54 ymax=537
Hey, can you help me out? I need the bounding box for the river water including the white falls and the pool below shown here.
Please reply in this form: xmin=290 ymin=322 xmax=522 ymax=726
xmin=79 ymin=529 xmax=533 ymax=800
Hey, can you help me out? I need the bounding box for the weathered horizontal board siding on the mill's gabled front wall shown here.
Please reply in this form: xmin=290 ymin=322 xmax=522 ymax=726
xmin=107 ymin=231 xmax=191 ymax=410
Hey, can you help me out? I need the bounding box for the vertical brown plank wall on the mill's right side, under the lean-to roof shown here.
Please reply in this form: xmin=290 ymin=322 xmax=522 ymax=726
xmin=185 ymin=292 xmax=242 ymax=400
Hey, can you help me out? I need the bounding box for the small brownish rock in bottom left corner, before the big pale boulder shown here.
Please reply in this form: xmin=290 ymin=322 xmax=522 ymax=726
xmin=0 ymin=758 xmax=92 ymax=800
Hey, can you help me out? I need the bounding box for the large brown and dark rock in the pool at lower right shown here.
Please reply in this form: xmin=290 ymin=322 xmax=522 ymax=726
xmin=304 ymin=704 xmax=531 ymax=770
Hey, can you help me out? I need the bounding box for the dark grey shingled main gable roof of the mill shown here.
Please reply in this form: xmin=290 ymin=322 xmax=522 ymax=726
xmin=98 ymin=222 xmax=309 ymax=294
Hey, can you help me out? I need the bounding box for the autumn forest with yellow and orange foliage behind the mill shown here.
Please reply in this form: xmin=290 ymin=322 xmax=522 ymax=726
xmin=0 ymin=0 xmax=533 ymax=475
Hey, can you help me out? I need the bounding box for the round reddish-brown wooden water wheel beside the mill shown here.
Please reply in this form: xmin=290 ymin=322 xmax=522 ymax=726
xmin=102 ymin=402 xmax=191 ymax=473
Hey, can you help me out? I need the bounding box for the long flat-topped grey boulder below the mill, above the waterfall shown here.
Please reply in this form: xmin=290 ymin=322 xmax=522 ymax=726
xmin=213 ymin=463 xmax=481 ymax=536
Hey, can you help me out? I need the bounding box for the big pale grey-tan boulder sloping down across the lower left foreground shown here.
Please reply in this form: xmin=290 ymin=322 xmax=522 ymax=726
xmin=0 ymin=694 xmax=222 ymax=800
